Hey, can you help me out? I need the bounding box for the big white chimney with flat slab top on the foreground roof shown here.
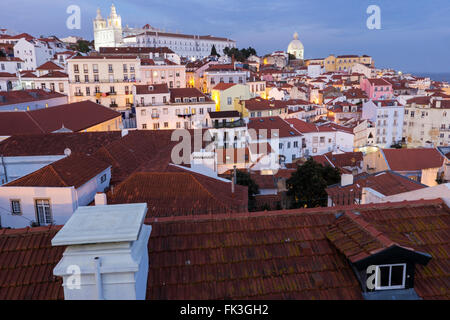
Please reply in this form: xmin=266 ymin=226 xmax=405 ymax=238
xmin=52 ymin=203 xmax=151 ymax=300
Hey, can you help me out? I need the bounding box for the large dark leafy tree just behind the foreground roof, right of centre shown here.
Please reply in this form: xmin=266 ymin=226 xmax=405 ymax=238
xmin=286 ymin=158 xmax=341 ymax=208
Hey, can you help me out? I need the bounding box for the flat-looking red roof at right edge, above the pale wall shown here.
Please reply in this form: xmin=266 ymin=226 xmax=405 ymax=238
xmin=382 ymin=148 xmax=444 ymax=171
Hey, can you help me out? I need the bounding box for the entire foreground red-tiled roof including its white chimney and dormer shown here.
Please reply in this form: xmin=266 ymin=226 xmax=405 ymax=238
xmin=0 ymin=199 xmax=450 ymax=300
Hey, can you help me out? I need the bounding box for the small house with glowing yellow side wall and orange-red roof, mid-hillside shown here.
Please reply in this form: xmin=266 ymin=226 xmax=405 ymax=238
xmin=211 ymin=83 xmax=252 ymax=111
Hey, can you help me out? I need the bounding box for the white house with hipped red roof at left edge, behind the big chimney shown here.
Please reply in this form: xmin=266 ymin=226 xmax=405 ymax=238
xmin=0 ymin=155 xmax=111 ymax=228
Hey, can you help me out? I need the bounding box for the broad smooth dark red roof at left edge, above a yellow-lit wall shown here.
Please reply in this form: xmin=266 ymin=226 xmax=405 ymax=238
xmin=0 ymin=100 xmax=121 ymax=136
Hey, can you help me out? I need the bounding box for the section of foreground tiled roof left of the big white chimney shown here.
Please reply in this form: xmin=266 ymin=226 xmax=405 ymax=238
xmin=0 ymin=226 xmax=65 ymax=300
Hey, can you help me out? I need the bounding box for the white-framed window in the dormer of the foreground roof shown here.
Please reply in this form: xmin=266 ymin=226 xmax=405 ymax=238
xmin=375 ymin=263 xmax=406 ymax=290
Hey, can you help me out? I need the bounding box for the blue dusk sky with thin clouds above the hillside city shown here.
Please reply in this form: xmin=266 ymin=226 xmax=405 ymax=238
xmin=0 ymin=0 xmax=450 ymax=72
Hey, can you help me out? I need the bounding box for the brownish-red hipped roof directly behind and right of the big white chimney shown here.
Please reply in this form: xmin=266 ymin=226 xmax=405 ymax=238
xmin=108 ymin=171 xmax=247 ymax=217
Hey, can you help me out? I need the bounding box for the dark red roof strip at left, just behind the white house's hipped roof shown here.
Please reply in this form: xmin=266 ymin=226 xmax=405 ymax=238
xmin=0 ymin=131 xmax=121 ymax=157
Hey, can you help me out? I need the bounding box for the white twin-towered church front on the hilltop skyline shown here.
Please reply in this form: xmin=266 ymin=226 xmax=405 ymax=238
xmin=94 ymin=4 xmax=122 ymax=51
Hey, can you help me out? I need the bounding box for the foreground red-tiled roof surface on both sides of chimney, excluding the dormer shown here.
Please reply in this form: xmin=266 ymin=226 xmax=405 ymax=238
xmin=0 ymin=199 xmax=450 ymax=300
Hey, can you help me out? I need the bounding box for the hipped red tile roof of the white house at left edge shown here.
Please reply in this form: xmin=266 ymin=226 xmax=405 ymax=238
xmin=3 ymin=154 xmax=110 ymax=188
